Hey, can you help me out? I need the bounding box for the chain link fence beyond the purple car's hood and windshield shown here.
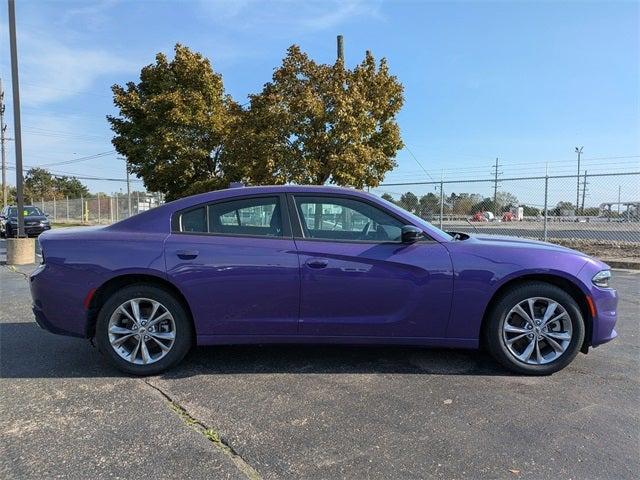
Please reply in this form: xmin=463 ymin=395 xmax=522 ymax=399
xmin=371 ymin=172 xmax=640 ymax=248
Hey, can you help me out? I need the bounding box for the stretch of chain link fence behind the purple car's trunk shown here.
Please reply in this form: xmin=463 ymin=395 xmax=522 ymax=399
xmin=28 ymin=192 xmax=163 ymax=225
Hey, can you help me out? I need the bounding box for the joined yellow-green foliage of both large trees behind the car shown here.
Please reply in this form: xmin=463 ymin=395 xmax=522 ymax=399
xmin=107 ymin=45 xmax=403 ymax=199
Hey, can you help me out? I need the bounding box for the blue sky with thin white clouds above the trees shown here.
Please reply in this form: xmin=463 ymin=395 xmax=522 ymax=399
xmin=0 ymin=0 xmax=640 ymax=201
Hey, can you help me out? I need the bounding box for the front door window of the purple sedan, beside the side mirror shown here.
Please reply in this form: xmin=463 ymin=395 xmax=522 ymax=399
xmin=295 ymin=196 xmax=403 ymax=242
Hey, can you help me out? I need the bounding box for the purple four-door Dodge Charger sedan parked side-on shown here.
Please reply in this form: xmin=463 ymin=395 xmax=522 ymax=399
xmin=31 ymin=186 xmax=617 ymax=375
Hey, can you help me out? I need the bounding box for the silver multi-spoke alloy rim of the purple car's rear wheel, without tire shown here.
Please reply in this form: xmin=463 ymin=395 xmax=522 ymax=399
xmin=108 ymin=298 xmax=176 ymax=365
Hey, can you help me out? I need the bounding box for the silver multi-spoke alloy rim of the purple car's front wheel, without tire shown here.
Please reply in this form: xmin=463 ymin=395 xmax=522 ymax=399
xmin=502 ymin=297 xmax=573 ymax=365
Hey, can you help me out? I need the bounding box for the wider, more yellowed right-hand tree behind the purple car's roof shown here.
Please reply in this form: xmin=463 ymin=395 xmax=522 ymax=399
xmin=225 ymin=45 xmax=403 ymax=188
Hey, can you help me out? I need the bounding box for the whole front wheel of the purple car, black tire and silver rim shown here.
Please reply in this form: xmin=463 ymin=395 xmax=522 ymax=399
xmin=484 ymin=282 xmax=585 ymax=375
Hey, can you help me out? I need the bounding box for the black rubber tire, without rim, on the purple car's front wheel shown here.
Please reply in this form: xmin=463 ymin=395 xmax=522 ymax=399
xmin=483 ymin=281 xmax=585 ymax=375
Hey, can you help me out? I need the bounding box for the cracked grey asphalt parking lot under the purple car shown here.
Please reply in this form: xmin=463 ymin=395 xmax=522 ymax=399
xmin=0 ymin=238 xmax=640 ymax=479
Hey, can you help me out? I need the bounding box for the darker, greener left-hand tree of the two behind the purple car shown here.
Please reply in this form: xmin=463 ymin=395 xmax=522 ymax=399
xmin=107 ymin=44 xmax=235 ymax=200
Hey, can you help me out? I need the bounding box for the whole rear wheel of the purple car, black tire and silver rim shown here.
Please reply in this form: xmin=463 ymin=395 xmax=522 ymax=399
xmin=95 ymin=285 xmax=193 ymax=375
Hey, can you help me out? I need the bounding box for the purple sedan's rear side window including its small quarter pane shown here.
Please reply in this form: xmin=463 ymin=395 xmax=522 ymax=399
xmin=180 ymin=197 xmax=283 ymax=237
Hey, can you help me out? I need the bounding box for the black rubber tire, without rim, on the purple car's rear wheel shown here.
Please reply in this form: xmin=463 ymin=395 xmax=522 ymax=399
xmin=95 ymin=284 xmax=194 ymax=375
